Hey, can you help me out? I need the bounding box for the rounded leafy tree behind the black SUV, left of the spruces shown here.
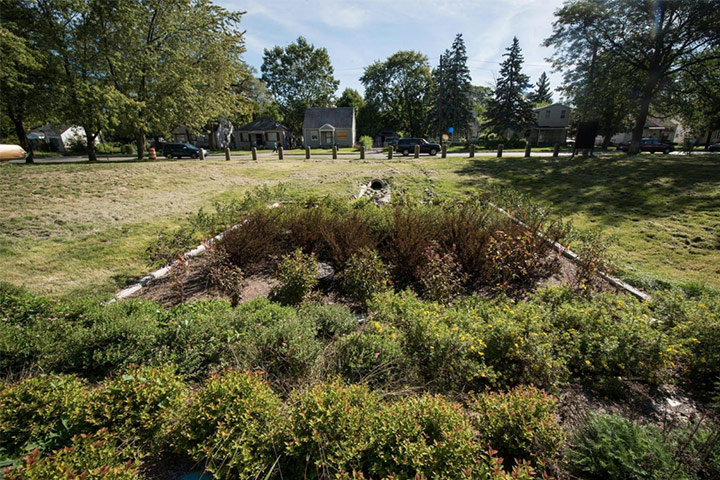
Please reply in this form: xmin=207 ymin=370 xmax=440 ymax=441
xmin=360 ymin=51 xmax=432 ymax=137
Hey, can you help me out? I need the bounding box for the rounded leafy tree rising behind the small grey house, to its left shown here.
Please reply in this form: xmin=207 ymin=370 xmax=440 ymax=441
xmin=260 ymin=37 xmax=340 ymax=132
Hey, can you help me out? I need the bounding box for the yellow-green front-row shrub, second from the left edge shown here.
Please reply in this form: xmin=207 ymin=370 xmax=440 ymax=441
xmin=88 ymin=367 xmax=186 ymax=448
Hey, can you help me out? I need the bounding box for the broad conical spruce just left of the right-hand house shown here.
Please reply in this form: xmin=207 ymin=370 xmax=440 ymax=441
xmin=485 ymin=37 xmax=535 ymax=138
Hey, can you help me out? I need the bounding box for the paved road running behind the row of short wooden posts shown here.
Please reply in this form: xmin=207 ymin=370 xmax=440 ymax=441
xmin=2 ymin=150 xmax=717 ymax=164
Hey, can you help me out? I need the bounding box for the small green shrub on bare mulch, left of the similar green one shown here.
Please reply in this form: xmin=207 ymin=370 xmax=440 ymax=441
xmin=270 ymin=249 xmax=318 ymax=305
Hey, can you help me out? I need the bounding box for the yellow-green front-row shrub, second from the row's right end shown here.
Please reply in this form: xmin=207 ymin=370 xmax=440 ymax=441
xmin=371 ymin=395 xmax=481 ymax=479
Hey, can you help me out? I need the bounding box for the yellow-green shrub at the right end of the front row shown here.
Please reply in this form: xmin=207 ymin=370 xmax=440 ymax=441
xmin=470 ymin=386 xmax=565 ymax=465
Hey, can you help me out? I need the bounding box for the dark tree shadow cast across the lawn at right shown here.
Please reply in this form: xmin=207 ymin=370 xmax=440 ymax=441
xmin=457 ymin=155 xmax=720 ymax=225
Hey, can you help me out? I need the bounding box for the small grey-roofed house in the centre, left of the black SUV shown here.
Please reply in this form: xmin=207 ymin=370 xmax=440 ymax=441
xmin=303 ymin=107 xmax=355 ymax=148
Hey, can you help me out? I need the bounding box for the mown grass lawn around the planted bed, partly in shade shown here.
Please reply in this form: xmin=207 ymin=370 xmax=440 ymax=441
xmin=0 ymin=155 xmax=720 ymax=295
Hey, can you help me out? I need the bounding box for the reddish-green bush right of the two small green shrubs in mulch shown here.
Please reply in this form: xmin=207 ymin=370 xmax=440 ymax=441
xmin=418 ymin=244 xmax=465 ymax=303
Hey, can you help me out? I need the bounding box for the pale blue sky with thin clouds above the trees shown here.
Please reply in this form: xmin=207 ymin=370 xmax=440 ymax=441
xmin=216 ymin=0 xmax=563 ymax=100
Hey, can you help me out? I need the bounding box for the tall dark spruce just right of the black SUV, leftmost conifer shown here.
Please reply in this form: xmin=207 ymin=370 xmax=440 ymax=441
xmin=430 ymin=33 xmax=474 ymax=136
